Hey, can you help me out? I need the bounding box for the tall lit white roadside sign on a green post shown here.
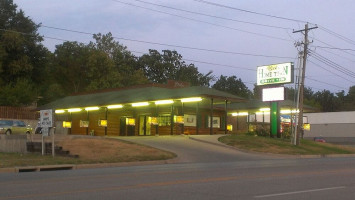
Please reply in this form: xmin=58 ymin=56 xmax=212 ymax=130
xmin=257 ymin=62 xmax=294 ymax=137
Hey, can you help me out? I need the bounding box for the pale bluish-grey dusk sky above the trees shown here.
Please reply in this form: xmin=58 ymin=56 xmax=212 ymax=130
xmin=14 ymin=0 xmax=355 ymax=93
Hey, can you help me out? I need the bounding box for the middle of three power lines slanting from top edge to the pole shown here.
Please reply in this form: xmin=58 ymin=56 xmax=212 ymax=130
xmin=126 ymin=0 xmax=293 ymax=30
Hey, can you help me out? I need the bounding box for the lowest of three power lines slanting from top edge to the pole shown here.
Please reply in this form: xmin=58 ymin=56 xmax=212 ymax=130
xmin=112 ymin=0 xmax=292 ymax=42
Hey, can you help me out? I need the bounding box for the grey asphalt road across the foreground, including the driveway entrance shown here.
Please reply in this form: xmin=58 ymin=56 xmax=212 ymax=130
xmin=0 ymin=135 xmax=355 ymax=200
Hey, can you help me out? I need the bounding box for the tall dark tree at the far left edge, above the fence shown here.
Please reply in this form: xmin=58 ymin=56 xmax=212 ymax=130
xmin=0 ymin=0 xmax=49 ymax=106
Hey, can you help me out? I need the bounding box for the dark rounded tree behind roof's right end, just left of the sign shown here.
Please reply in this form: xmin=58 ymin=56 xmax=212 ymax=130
xmin=212 ymin=75 xmax=252 ymax=99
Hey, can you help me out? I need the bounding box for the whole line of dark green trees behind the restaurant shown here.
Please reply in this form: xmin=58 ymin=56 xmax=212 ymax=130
xmin=0 ymin=0 xmax=355 ymax=111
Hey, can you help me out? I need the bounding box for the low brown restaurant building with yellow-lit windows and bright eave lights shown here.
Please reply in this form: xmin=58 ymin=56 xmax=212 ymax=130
xmin=39 ymin=81 xmax=246 ymax=136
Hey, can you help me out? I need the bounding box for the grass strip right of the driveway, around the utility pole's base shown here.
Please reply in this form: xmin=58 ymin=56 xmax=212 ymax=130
xmin=219 ymin=134 xmax=355 ymax=155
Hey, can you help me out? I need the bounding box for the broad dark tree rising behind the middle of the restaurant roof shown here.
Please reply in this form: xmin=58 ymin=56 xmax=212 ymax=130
xmin=139 ymin=49 xmax=214 ymax=86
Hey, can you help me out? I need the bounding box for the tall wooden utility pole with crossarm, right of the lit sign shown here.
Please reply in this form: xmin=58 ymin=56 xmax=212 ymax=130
xmin=293 ymin=23 xmax=318 ymax=145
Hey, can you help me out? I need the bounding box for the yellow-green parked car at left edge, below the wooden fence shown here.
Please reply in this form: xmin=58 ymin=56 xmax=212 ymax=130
xmin=0 ymin=120 xmax=32 ymax=135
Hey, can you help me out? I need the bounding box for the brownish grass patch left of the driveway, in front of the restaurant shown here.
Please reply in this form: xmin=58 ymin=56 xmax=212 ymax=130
xmin=0 ymin=138 xmax=176 ymax=168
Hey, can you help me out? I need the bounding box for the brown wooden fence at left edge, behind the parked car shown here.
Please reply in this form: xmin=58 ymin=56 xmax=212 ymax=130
xmin=0 ymin=106 xmax=39 ymax=120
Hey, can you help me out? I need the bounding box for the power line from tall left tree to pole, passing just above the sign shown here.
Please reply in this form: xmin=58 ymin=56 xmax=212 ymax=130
xmin=41 ymin=24 xmax=292 ymax=59
